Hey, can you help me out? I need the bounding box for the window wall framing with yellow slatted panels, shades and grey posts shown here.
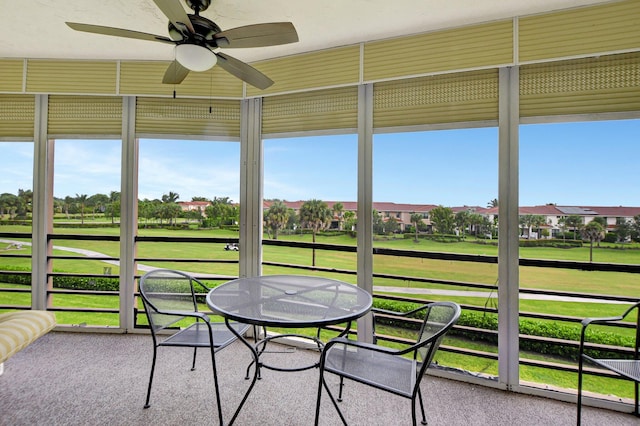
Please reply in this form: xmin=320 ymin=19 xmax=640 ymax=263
xmin=0 ymin=0 xmax=640 ymax=414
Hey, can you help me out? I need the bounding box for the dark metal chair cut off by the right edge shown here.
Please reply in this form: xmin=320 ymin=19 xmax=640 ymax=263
xmin=577 ymin=303 xmax=640 ymax=425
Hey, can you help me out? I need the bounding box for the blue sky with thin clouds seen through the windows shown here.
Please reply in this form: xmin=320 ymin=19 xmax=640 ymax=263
xmin=0 ymin=120 xmax=640 ymax=206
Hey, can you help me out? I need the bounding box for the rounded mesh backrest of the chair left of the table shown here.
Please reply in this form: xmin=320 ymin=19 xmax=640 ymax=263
xmin=139 ymin=269 xmax=209 ymax=332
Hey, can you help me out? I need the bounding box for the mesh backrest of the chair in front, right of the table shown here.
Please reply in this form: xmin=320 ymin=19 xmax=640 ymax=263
xmin=415 ymin=302 xmax=461 ymax=368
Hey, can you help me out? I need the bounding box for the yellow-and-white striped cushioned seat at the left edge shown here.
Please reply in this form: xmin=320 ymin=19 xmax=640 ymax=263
xmin=0 ymin=310 xmax=56 ymax=374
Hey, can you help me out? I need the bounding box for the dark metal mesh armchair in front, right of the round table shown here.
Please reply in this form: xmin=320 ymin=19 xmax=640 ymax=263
xmin=315 ymin=302 xmax=460 ymax=425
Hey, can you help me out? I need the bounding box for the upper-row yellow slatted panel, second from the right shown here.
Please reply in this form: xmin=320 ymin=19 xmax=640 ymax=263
xmin=363 ymin=20 xmax=514 ymax=81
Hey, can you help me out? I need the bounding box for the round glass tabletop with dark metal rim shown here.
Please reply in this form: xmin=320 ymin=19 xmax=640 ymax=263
xmin=207 ymin=275 xmax=372 ymax=328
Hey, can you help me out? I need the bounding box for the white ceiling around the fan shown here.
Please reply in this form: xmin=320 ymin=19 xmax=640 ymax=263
xmin=0 ymin=0 xmax=604 ymax=64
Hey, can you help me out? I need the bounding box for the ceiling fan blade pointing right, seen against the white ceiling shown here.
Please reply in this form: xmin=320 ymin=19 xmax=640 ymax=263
xmin=215 ymin=22 xmax=298 ymax=47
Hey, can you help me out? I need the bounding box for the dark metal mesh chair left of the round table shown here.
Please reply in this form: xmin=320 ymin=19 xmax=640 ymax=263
xmin=140 ymin=269 xmax=249 ymax=424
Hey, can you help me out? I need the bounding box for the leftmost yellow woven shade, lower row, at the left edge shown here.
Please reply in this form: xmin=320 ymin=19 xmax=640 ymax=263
xmin=0 ymin=95 xmax=35 ymax=138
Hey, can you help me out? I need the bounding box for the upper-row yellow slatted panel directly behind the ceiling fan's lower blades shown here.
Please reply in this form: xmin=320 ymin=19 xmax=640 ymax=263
xmin=120 ymin=61 xmax=242 ymax=98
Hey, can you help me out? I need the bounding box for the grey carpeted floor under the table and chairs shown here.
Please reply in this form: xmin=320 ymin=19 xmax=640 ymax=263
xmin=0 ymin=332 xmax=640 ymax=426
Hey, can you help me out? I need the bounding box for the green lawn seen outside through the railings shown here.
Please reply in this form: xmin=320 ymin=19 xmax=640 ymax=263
xmin=0 ymin=226 xmax=640 ymax=397
